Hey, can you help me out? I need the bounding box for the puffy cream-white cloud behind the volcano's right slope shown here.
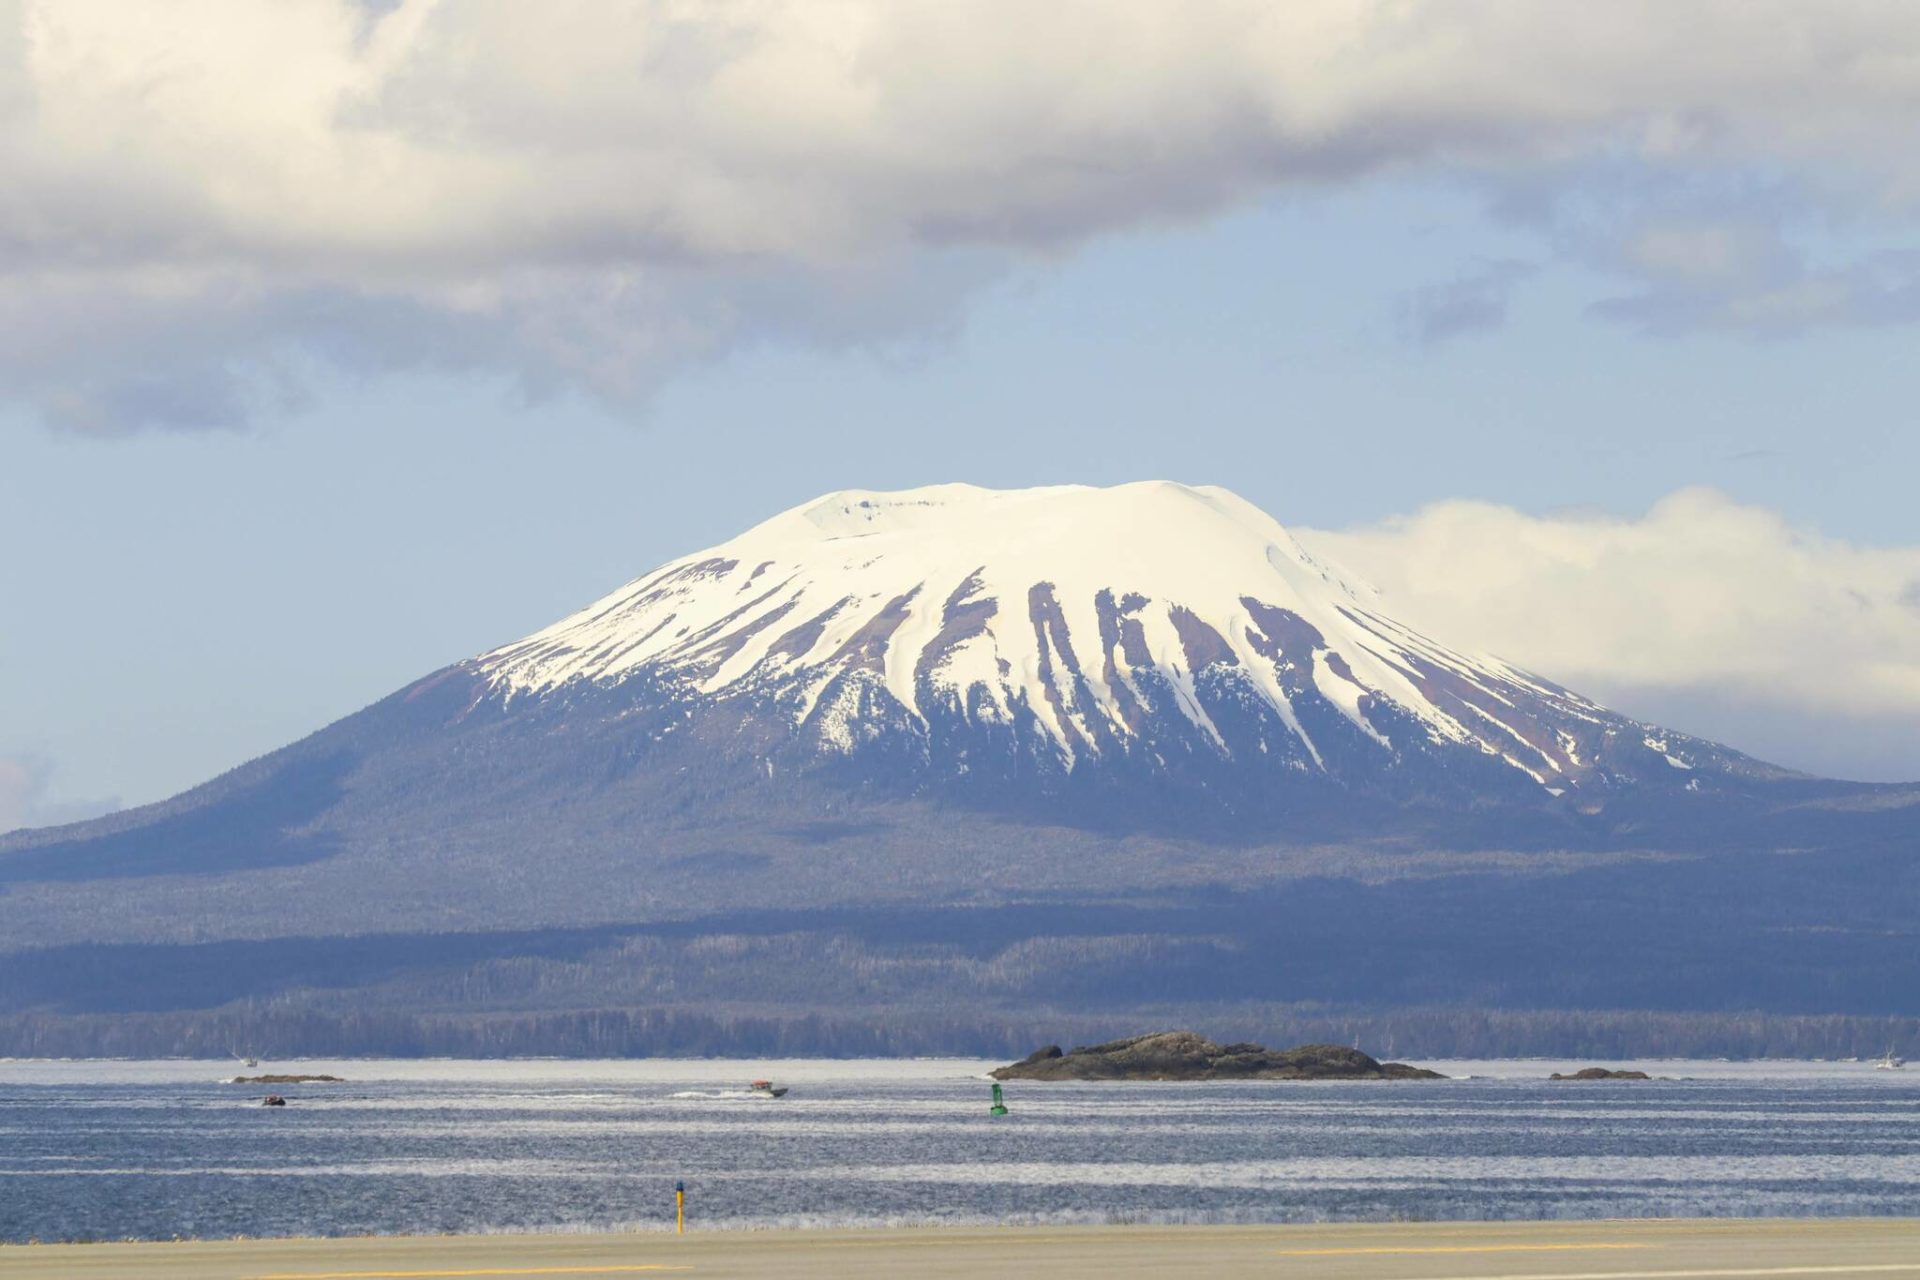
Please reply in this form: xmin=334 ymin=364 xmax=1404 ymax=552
xmin=1302 ymin=489 xmax=1920 ymax=779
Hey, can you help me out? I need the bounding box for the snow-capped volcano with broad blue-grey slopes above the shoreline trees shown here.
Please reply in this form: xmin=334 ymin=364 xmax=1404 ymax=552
xmin=0 ymin=484 xmax=1920 ymax=1052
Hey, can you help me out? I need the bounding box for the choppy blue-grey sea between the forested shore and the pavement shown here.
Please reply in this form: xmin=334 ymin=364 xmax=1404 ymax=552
xmin=0 ymin=1061 xmax=1920 ymax=1242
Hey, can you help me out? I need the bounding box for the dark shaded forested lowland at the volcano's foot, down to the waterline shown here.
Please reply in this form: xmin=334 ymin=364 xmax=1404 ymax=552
xmin=0 ymin=860 xmax=1920 ymax=1057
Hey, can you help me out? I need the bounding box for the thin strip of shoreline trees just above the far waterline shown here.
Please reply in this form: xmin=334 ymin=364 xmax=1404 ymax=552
xmin=0 ymin=1004 xmax=1920 ymax=1061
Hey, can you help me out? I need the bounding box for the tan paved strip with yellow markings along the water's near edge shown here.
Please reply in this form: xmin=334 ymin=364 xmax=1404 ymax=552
xmin=0 ymin=1219 xmax=1920 ymax=1280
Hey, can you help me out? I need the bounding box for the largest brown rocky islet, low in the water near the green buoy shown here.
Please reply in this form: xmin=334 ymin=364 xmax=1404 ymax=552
xmin=991 ymin=1031 xmax=1446 ymax=1080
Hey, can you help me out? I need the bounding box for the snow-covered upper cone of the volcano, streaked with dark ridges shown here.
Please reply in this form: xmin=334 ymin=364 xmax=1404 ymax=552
xmin=472 ymin=482 xmax=1759 ymax=796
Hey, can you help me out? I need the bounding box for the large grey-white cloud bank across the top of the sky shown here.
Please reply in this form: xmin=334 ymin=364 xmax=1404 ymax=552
xmin=0 ymin=0 xmax=1920 ymax=430
